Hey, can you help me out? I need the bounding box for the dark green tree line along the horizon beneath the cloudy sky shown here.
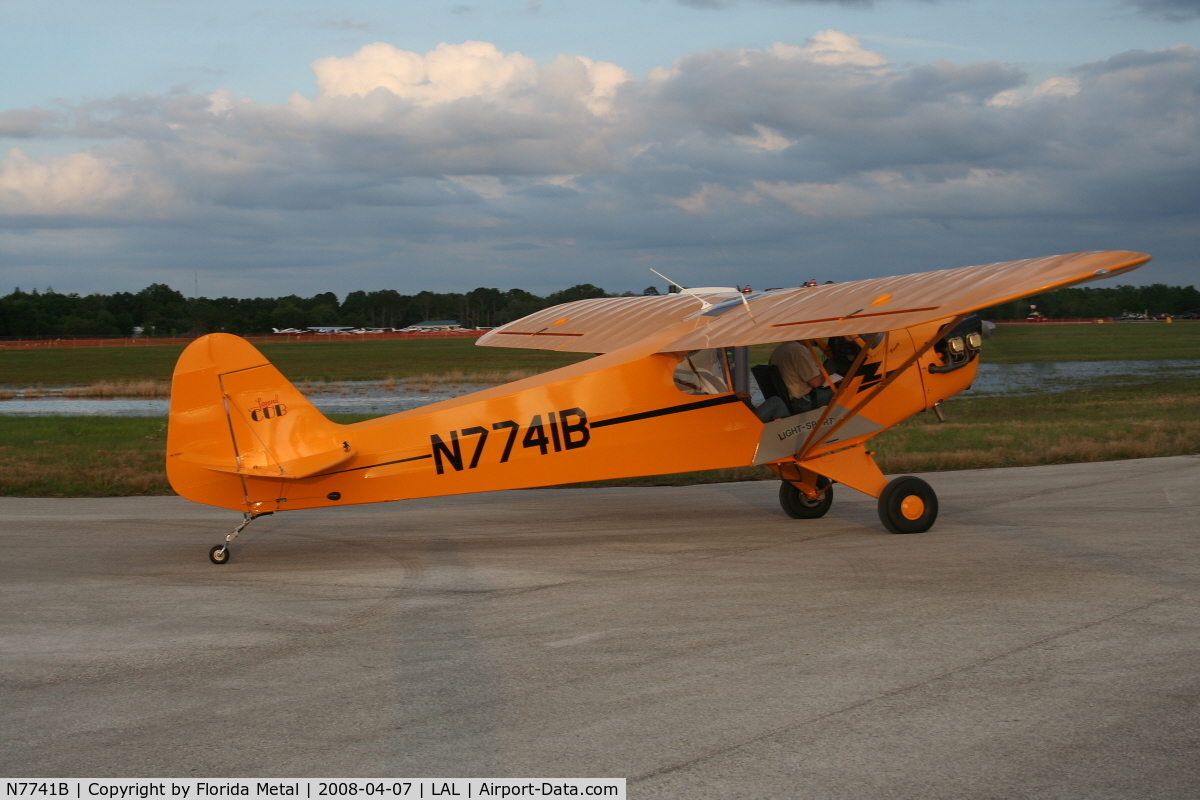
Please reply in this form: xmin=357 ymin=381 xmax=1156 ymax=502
xmin=0 ymin=283 xmax=1200 ymax=337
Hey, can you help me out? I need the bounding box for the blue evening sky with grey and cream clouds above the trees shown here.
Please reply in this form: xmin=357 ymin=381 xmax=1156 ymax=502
xmin=0 ymin=0 xmax=1200 ymax=296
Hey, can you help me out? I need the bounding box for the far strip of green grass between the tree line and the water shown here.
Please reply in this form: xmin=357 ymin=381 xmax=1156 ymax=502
xmin=0 ymin=320 xmax=1200 ymax=386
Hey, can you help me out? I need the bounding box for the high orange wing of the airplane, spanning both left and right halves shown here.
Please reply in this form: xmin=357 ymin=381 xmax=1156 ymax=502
xmin=478 ymin=251 xmax=1150 ymax=353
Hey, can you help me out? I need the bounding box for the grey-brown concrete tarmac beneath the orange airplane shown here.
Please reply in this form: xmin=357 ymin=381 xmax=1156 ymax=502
xmin=0 ymin=456 xmax=1200 ymax=800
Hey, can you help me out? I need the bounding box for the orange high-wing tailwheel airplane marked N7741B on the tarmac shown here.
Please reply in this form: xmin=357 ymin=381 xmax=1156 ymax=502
xmin=167 ymin=251 xmax=1150 ymax=564
